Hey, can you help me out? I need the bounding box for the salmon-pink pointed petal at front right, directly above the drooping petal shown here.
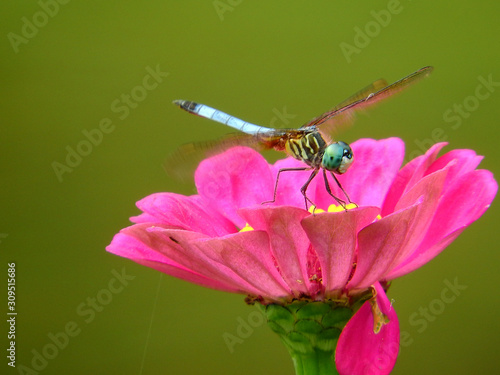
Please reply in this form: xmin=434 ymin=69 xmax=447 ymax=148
xmin=347 ymin=201 xmax=421 ymax=289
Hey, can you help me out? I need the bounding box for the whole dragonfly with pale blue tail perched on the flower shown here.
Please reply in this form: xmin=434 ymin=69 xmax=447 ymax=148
xmin=166 ymin=66 xmax=433 ymax=210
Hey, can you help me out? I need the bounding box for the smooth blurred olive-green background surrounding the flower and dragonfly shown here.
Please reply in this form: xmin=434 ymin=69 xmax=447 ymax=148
xmin=0 ymin=0 xmax=500 ymax=374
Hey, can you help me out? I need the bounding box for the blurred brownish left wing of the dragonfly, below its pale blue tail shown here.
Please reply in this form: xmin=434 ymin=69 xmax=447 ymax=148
xmin=164 ymin=133 xmax=267 ymax=181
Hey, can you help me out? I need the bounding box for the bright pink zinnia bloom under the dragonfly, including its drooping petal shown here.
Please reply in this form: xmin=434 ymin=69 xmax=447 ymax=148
xmin=107 ymin=138 xmax=498 ymax=374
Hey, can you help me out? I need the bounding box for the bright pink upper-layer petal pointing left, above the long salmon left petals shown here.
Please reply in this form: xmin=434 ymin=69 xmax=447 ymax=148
xmin=131 ymin=193 xmax=236 ymax=236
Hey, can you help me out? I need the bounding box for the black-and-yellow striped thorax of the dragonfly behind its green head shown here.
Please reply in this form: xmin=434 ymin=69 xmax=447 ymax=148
xmin=285 ymin=131 xmax=327 ymax=167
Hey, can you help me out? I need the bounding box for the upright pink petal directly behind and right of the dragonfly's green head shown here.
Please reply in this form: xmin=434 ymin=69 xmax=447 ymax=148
xmin=316 ymin=138 xmax=404 ymax=207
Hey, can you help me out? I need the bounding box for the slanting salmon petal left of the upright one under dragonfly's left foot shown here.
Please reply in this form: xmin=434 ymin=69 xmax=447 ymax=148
xmin=194 ymin=231 xmax=291 ymax=299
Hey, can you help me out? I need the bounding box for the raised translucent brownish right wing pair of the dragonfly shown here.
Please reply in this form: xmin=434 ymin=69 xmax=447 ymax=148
xmin=302 ymin=66 xmax=433 ymax=137
